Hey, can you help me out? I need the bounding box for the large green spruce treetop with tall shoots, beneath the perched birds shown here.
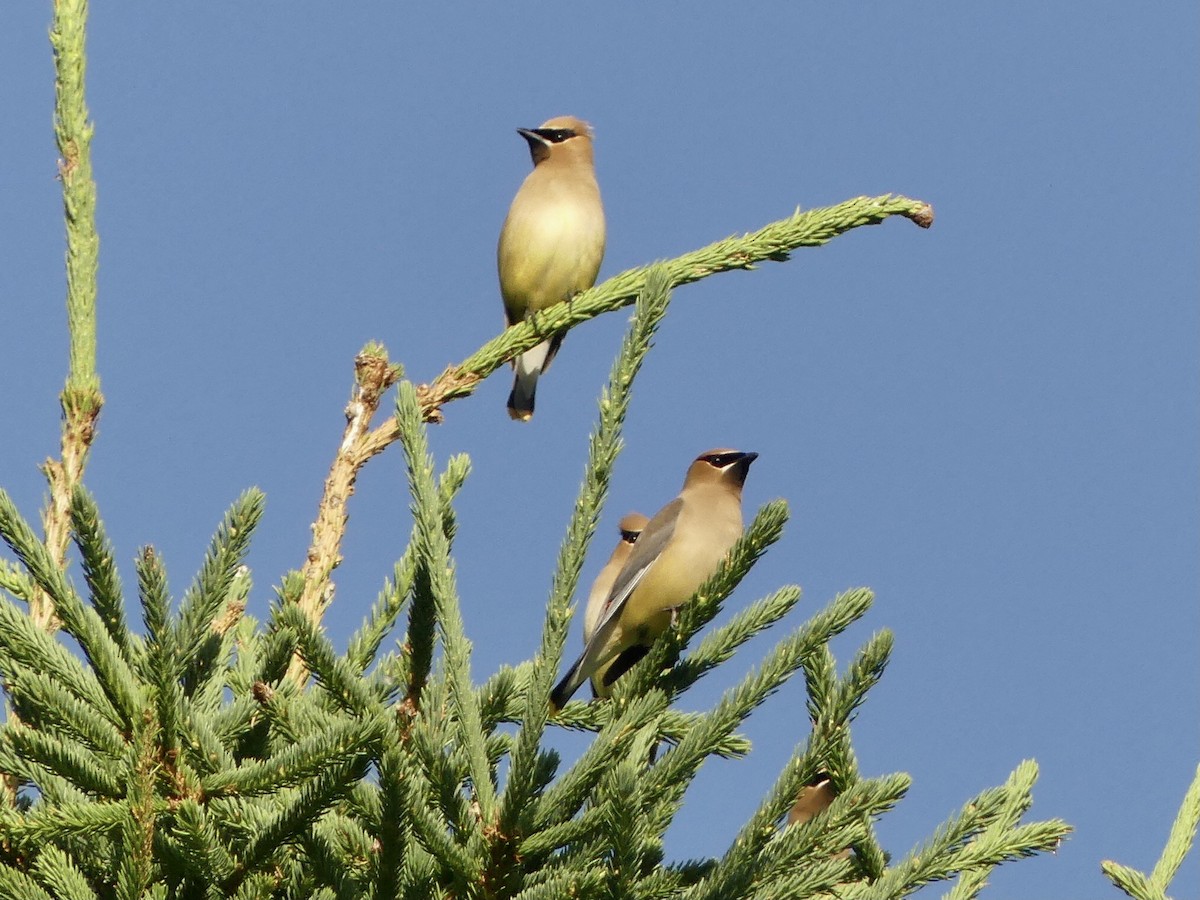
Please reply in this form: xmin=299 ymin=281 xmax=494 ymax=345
xmin=0 ymin=0 xmax=1104 ymax=900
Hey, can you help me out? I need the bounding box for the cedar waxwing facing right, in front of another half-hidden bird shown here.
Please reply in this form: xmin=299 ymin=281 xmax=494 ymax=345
xmin=550 ymin=450 xmax=758 ymax=710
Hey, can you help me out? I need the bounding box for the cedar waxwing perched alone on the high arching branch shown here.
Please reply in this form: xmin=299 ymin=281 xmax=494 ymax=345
xmin=496 ymin=115 xmax=605 ymax=421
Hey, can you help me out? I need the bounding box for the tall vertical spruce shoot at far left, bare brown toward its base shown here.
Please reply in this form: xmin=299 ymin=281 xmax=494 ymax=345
xmin=30 ymin=0 xmax=104 ymax=629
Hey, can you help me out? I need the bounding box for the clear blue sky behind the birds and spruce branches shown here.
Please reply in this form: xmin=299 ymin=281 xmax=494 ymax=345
xmin=0 ymin=2 xmax=1200 ymax=898
